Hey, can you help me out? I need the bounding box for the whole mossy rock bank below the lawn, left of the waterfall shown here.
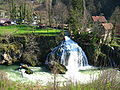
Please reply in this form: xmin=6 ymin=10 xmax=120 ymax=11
xmin=0 ymin=35 xmax=60 ymax=66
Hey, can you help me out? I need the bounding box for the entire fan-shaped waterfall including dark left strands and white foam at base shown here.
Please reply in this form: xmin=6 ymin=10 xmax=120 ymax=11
xmin=46 ymin=36 xmax=91 ymax=81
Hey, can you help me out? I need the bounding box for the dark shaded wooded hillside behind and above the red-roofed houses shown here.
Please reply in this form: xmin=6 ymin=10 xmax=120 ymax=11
xmin=86 ymin=0 xmax=120 ymax=19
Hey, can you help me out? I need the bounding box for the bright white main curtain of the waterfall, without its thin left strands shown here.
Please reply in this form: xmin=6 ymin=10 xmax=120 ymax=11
xmin=60 ymin=36 xmax=88 ymax=71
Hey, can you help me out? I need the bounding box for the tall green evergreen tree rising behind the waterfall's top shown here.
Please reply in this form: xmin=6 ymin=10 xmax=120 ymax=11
xmin=70 ymin=0 xmax=84 ymax=34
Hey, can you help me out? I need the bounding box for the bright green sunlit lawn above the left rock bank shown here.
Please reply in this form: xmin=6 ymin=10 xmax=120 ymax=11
xmin=0 ymin=25 xmax=61 ymax=35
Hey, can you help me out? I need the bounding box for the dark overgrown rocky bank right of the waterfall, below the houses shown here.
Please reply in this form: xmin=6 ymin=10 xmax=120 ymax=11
xmin=74 ymin=32 xmax=120 ymax=67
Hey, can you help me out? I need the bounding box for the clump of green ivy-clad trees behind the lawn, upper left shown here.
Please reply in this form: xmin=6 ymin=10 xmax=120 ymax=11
xmin=7 ymin=0 xmax=33 ymax=24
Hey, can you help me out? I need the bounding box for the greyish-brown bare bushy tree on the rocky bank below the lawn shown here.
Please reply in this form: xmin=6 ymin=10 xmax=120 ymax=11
xmin=23 ymin=34 xmax=39 ymax=66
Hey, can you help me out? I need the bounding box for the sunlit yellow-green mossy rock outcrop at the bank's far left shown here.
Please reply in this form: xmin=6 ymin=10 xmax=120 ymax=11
xmin=0 ymin=43 xmax=23 ymax=65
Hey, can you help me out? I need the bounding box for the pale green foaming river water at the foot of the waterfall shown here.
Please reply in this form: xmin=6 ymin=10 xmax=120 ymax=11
xmin=0 ymin=65 xmax=120 ymax=86
